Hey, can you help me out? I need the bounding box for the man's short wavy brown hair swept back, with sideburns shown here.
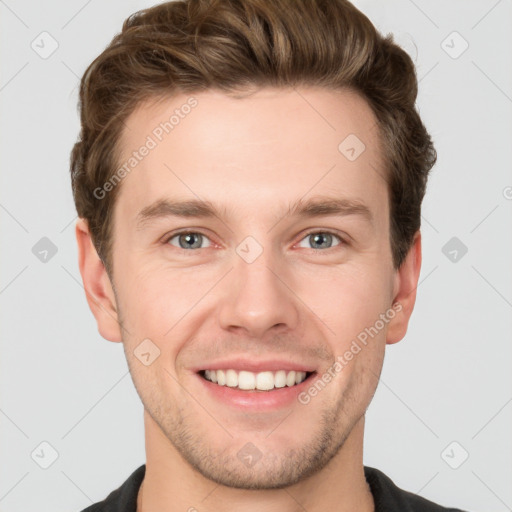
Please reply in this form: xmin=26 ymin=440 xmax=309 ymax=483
xmin=71 ymin=0 xmax=437 ymax=274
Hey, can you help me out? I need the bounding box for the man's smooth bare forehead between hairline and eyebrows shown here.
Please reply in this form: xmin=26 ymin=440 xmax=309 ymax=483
xmin=116 ymin=88 xmax=387 ymax=228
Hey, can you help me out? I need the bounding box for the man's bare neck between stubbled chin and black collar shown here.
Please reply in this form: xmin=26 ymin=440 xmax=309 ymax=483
xmin=137 ymin=412 xmax=375 ymax=512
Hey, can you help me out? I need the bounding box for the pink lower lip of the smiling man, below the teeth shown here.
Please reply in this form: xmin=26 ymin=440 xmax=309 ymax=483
xmin=196 ymin=373 xmax=315 ymax=411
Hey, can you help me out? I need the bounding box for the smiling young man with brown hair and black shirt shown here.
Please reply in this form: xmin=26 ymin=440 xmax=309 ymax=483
xmin=71 ymin=0 xmax=468 ymax=512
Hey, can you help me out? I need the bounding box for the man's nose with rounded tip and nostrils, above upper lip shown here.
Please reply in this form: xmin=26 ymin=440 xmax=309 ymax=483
xmin=218 ymin=251 xmax=299 ymax=339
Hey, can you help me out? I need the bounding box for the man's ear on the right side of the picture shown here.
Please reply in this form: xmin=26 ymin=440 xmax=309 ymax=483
xmin=386 ymin=231 xmax=421 ymax=345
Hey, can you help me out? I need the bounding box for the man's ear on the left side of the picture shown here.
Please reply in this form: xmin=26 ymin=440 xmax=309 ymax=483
xmin=75 ymin=218 xmax=122 ymax=342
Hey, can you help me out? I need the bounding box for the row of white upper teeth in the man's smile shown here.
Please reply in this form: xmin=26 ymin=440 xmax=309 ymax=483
xmin=204 ymin=369 xmax=306 ymax=391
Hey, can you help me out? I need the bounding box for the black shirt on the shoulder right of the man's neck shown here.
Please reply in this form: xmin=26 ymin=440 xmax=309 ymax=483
xmin=364 ymin=466 xmax=464 ymax=512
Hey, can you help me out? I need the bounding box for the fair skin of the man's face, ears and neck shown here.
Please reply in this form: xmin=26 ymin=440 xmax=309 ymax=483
xmin=76 ymin=88 xmax=421 ymax=512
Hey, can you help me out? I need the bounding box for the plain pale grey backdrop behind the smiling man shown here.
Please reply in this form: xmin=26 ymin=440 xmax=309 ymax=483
xmin=0 ymin=0 xmax=512 ymax=512
